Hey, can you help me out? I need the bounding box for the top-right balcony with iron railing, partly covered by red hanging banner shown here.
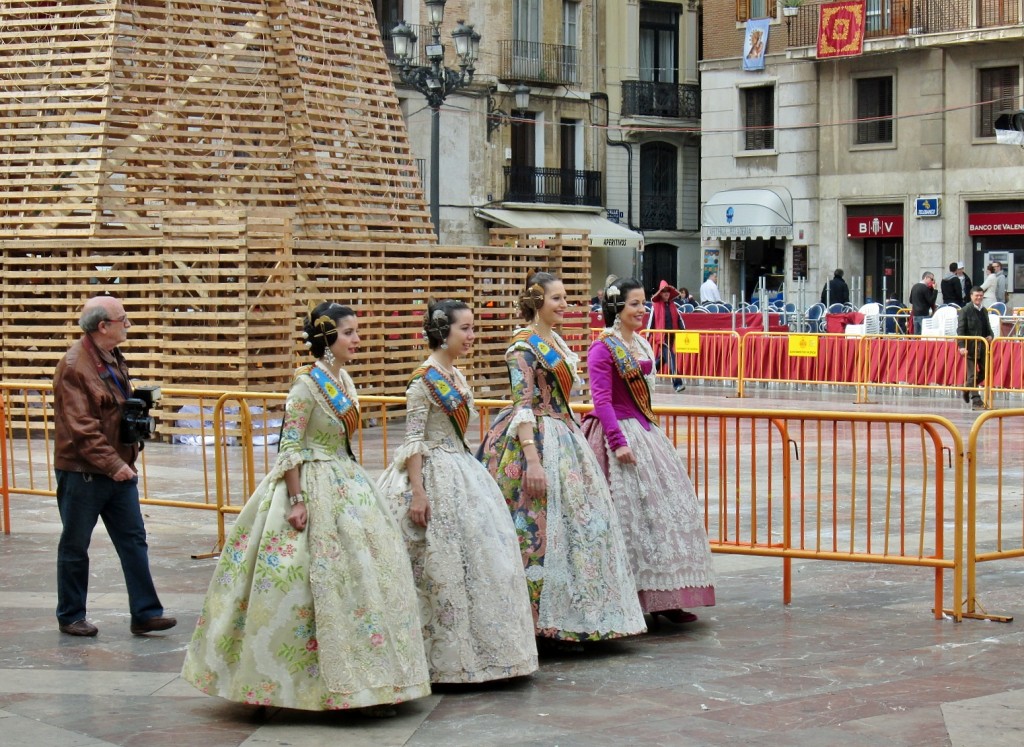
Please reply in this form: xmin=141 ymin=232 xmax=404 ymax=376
xmin=783 ymin=0 xmax=1024 ymax=47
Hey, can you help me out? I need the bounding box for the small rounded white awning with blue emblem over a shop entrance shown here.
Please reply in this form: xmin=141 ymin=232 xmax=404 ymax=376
xmin=700 ymin=188 xmax=793 ymax=240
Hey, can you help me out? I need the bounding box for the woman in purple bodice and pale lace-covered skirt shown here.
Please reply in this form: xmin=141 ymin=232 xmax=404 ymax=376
xmin=583 ymin=279 xmax=715 ymax=623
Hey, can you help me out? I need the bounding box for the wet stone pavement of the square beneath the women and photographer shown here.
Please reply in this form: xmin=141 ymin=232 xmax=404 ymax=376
xmin=0 ymin=386 xmax=1024 ymax=747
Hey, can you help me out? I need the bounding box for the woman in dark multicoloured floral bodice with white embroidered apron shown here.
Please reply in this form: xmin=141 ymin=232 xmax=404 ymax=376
xmin=481 ymin=273 xmax=646 ymax=640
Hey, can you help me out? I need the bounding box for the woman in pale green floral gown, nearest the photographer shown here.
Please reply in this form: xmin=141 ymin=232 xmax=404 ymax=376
xmin=182 ymin=303 xmax=430 ymax=714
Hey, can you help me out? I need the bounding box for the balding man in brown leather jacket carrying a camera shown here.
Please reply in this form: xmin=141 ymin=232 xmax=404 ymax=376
xmin=53 ymin=296 xmax=177 ymax=635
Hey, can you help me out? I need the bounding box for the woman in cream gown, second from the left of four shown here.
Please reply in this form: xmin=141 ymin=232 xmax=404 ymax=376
xmin=378 ymin=300 xmax=537 ymax=682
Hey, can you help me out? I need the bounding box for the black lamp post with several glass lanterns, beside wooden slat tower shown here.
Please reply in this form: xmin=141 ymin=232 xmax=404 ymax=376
xmin=391 ymin=0 xmax=480 ymax=241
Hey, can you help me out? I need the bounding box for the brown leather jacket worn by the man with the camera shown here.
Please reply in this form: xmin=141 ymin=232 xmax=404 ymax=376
xmin=53 ymin=336 xmax=138 ymax=478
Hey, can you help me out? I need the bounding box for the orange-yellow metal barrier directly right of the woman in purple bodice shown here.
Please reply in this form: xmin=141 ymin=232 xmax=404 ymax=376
xmin=655 ymin=408 xmax=964 ymax=621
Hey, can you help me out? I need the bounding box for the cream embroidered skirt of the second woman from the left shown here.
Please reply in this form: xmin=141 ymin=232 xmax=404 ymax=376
xmin=378 ymin=448 xmax=538 ymax=682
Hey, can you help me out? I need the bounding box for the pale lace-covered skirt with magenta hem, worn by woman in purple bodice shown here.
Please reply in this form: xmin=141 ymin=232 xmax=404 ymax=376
xmin=583 ymin=417 xmax=715 ymax=612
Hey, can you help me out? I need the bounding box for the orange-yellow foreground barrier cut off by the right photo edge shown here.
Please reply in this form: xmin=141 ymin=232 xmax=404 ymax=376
xmin=964 ymin=409 xmax=1024 ymax=622
